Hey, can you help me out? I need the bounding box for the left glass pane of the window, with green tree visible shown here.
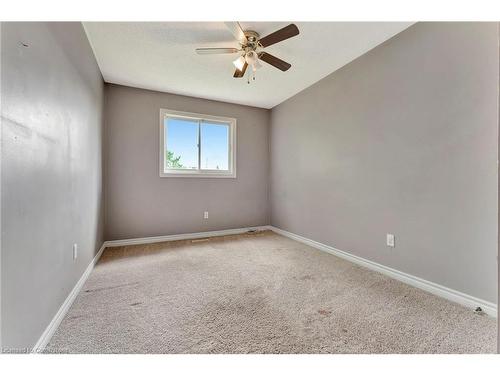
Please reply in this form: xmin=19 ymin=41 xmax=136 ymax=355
xmin=165 ymin=117 xmax=198 ymax=169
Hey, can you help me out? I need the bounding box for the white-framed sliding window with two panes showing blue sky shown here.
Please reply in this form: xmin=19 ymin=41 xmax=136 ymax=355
xmin=160 ymin=109 xmax=236 ymax=178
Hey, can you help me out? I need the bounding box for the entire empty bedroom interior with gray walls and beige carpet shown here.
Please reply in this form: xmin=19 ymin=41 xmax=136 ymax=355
xmin=0 ymin=20 xmax=500 ymax=354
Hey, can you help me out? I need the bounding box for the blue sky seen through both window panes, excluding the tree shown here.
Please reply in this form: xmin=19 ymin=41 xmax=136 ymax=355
xmin=164 ymin=118 xmax=229 ymax=170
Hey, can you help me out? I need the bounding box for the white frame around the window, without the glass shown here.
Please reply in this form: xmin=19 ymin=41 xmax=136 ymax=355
xmin=159 ymin=108 xmax=236 ymax=178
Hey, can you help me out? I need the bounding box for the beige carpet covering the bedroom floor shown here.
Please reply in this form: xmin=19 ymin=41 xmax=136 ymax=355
xmin=46 ymin=232 xmax=496 ymax=353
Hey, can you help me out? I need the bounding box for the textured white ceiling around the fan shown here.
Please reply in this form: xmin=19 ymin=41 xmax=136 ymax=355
xmin=84 ymin=22 xmax=412 ymax=108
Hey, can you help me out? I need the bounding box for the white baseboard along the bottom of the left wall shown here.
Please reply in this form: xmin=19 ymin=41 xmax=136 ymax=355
xmin=31 ymin=244 xmax=106 ymax=353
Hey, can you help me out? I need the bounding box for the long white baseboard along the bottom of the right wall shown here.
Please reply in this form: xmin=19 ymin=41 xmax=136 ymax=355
xmin=268 ymin=226 xmax=497 ymax=318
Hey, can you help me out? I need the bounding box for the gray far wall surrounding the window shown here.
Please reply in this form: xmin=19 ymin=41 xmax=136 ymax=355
xmin=105 ymin=84 xmax=269 ymax=240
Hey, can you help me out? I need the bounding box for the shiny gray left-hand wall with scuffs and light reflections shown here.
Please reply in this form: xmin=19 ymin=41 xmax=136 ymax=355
xmin=1 ymin=23 xmax=103 ymax=348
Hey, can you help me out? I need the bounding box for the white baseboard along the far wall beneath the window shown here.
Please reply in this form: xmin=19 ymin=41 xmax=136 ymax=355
xmin=104 ymin=225 xmax=269 ymax=247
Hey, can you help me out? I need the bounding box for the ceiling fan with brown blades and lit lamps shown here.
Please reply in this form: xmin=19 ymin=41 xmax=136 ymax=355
xmin=196 ymin=22 xmax=299 ymax=83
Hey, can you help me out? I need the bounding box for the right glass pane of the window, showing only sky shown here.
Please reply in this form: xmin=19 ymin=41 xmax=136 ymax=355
xmin=200 ymin=121 xmax=229 ymax=171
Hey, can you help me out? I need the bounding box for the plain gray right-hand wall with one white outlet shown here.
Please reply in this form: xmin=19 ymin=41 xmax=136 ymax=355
xmin=271 ymin=23 xmax=499 ymax=302
